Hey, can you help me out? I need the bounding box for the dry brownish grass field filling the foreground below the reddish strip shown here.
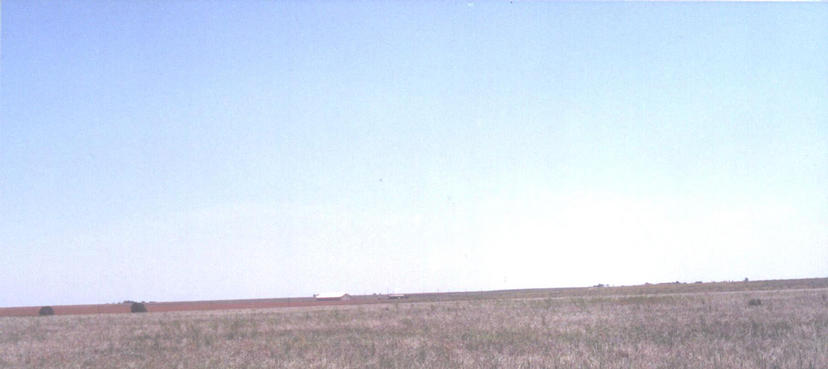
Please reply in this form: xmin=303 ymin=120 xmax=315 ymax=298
xmin=0 ymin=280 xmax=828 ymax=369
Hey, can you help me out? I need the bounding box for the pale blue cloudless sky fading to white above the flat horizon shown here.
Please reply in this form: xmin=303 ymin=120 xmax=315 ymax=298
xmin=0 ymin=0 xmax=828 ymax=306
